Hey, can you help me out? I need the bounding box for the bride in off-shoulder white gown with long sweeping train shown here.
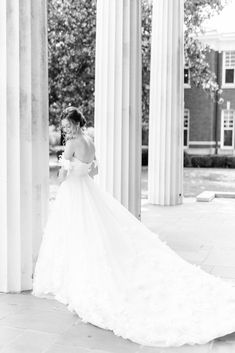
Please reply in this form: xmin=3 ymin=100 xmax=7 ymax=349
xmin=33 ymin=107 xmax=235 ymax=347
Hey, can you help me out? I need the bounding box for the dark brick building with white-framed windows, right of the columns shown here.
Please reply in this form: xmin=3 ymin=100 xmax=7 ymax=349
xmin=184 ymin=32 xmax=235 ymax=155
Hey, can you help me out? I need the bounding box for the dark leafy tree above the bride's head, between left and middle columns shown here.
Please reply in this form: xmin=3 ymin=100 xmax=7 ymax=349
xmin=48 ymin=0 xmax=96 ymax=125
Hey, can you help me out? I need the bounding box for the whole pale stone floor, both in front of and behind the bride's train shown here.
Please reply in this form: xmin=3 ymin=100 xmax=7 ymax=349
xmin=0 ymin=198 xmax=235 ymax=353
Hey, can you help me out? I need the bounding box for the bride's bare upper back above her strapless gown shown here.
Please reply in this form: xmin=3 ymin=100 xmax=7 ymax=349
xmin=73 ymin=133 xmax=95 ymax=163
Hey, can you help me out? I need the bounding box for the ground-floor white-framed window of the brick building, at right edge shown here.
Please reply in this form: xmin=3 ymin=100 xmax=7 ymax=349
xmin=221 ymin=110 xmax=235 ymax=149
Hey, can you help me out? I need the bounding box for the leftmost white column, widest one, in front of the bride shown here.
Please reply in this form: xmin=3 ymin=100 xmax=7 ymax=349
xmin=0 ymin=0 xmax=48 ymax=292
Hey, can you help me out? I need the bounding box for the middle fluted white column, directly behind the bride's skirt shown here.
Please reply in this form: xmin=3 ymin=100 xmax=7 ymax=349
xmin=95 ymin=0 xmax=141 ymax=217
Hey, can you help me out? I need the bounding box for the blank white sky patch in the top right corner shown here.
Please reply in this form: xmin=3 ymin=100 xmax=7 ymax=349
xmin=205 ymin=0 xmax=235 ymax=33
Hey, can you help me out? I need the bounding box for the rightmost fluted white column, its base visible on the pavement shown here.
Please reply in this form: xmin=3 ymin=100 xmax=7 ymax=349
xmin=148 ymin=0 xmax=184 ymax=205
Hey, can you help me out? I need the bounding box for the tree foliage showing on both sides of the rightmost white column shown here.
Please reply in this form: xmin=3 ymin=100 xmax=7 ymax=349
xmin=142 ymin=0 xmax=226 ymax=123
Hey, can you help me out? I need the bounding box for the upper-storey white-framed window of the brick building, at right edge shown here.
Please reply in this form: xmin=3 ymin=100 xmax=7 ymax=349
xmin=223 ymin=50 xmax=235 ymax=88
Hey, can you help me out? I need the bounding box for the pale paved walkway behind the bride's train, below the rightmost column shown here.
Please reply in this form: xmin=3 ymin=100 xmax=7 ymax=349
xmin=142 ymin=198 xmax=235 ymax=280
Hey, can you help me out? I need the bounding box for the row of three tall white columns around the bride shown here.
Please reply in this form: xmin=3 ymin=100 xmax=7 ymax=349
xmin=0 ymin=0 xmax=183 ymax=292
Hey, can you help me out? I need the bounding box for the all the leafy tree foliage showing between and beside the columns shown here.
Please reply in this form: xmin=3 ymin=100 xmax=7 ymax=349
xmin=48 ymin=0 xmax=226 ymax=125
